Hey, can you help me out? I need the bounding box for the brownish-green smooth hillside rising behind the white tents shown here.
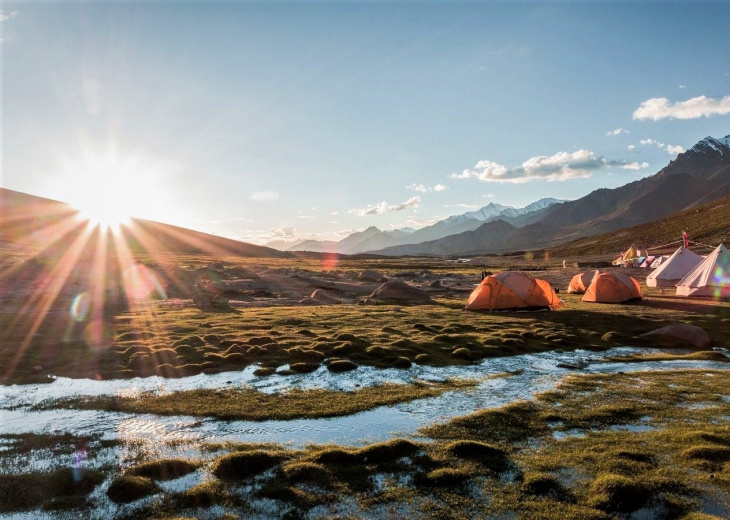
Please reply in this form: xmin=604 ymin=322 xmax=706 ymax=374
xmin=547 ymin=195 xmax=730 ymax=257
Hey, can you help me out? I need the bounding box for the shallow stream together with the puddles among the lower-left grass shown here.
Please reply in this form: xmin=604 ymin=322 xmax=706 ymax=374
xmin=0 ymin=347 xmax=727 ymax=520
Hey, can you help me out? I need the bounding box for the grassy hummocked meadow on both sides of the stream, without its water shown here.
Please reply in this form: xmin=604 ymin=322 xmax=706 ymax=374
xmin=0 ymin=251 xmax=730 ymax=520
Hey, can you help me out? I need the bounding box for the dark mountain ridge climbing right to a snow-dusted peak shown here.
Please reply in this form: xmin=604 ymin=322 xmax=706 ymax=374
xmin=370 ymin=135 xmax=730 ymax=255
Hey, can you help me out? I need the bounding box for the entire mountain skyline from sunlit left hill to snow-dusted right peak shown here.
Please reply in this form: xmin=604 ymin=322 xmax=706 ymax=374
xmin=0 ymin=135 xmax=730 ymax=258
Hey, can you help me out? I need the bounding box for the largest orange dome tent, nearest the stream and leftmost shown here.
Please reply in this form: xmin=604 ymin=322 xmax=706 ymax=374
xmin=466 ymin=271 xmax=564 ymax=311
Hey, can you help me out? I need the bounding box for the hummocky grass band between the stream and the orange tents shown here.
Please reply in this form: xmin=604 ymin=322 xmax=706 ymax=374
xmin=5 ymin=256 xmax=730 ymax=383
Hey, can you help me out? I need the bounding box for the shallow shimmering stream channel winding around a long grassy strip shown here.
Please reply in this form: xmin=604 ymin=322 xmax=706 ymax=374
xmin=0 ymin=347 xmax=726 ymax=447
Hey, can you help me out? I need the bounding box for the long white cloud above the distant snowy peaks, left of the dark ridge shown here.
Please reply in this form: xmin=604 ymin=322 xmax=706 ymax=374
xmin=450 ymin=150 xmax=628 ymax=183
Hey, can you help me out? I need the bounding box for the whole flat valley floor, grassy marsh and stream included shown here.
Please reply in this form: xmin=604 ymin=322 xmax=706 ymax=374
xmin=0 ymin=238 xmax=730 ymax=518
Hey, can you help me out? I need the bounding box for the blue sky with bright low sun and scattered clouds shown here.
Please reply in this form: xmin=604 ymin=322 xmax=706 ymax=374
xmin=0 ymin=0 xmax=730 ymax=243
